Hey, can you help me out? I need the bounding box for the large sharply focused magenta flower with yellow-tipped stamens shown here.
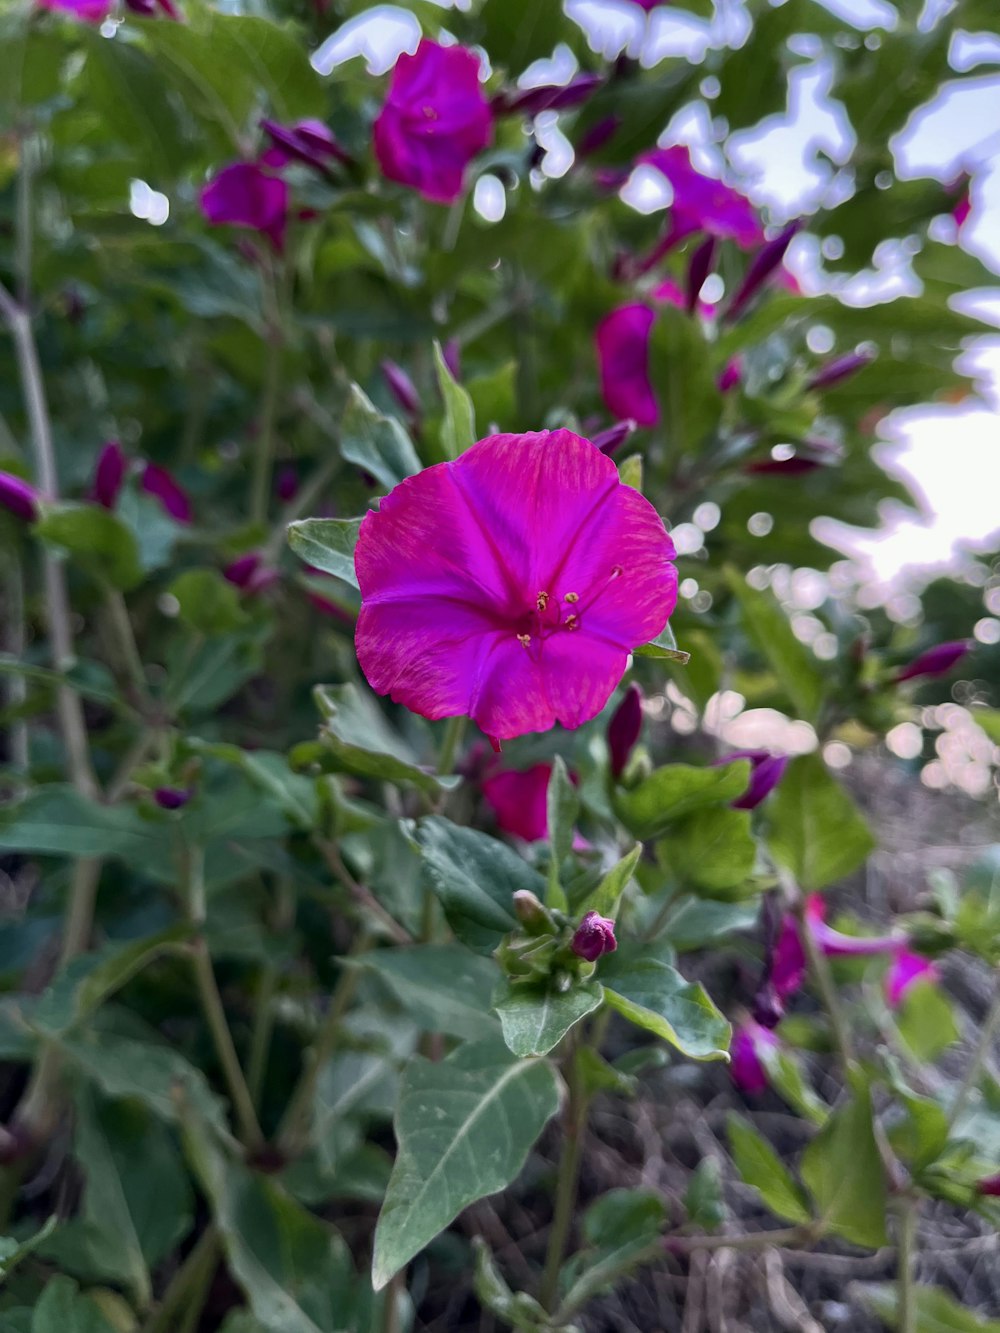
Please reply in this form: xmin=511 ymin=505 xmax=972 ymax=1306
xmin=355 ymin=431 xmax=677 ymax=740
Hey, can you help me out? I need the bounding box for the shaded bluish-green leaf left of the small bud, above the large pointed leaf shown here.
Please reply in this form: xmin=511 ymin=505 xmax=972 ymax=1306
xmin=357 ymin=944 xmax=499 ymax=1040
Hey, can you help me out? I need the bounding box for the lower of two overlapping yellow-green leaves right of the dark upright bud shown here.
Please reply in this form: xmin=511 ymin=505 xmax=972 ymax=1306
xmin=656 ymin=805 xmax=757 ymax=900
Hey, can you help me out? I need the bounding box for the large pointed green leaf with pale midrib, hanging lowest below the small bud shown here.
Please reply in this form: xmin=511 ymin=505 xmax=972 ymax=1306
xmin=372 ymin=1042 xmax=560 ymax=1290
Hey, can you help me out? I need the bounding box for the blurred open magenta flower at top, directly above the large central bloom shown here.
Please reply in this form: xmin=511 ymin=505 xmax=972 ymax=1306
xmin=373 ymin=39 xmax=493 ymax=204
